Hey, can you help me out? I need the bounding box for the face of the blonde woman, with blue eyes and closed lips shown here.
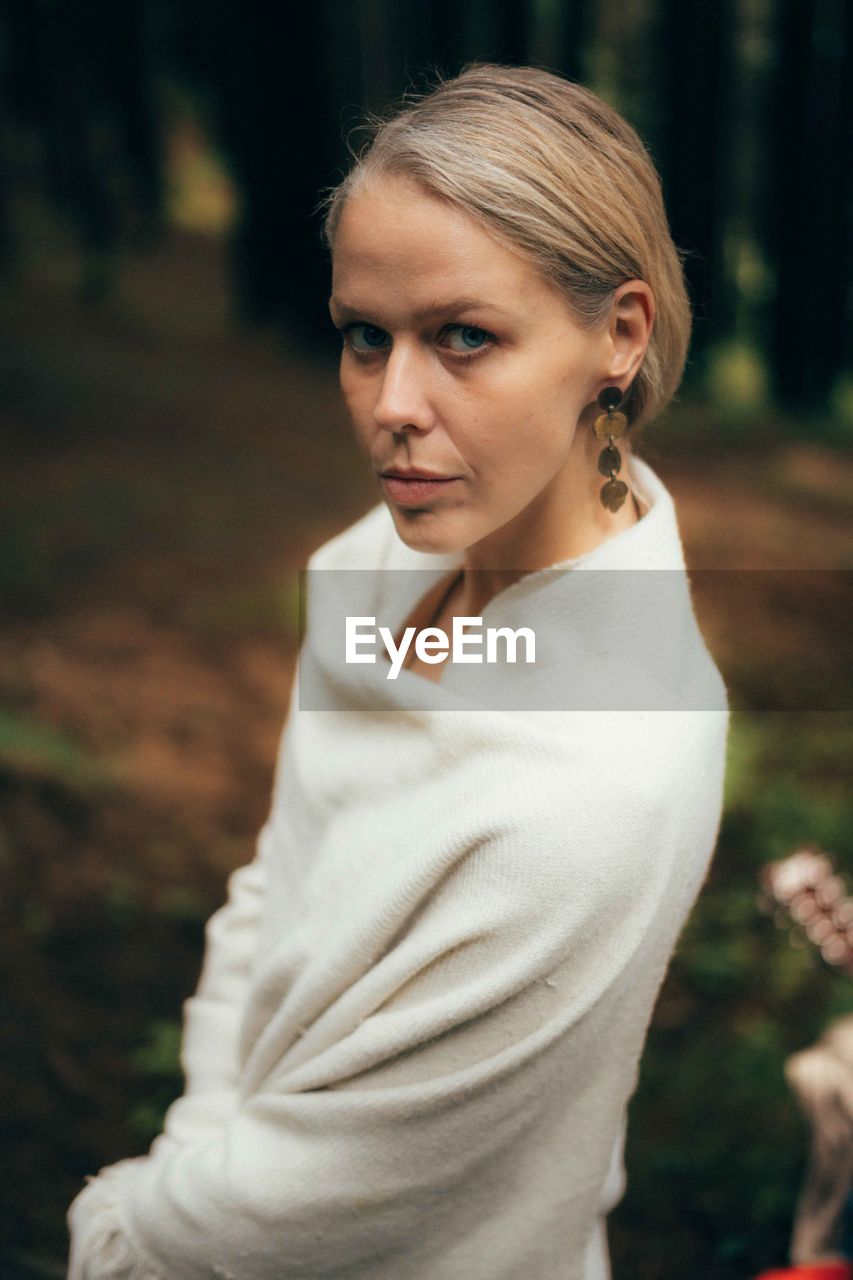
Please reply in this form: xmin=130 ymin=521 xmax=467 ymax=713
xmin=329 ymin=177 xmax=635 ymax=563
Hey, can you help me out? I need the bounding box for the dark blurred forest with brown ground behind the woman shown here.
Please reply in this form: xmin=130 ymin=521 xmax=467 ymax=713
xmin=0 ymin=0 xmax=853 ymax=1280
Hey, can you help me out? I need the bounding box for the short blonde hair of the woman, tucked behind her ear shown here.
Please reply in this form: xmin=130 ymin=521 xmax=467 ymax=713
xmin=318 ymin=63 xmax=690 ymax=435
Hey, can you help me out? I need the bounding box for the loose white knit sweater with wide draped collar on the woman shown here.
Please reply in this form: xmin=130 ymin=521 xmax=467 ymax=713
xmin=68 ymin=457 xmax=727 ymax=1280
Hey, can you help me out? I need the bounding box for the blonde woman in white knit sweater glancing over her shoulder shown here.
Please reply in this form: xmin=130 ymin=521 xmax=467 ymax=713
xmin=69 ymin=64 xmax=727 ymax=1280
